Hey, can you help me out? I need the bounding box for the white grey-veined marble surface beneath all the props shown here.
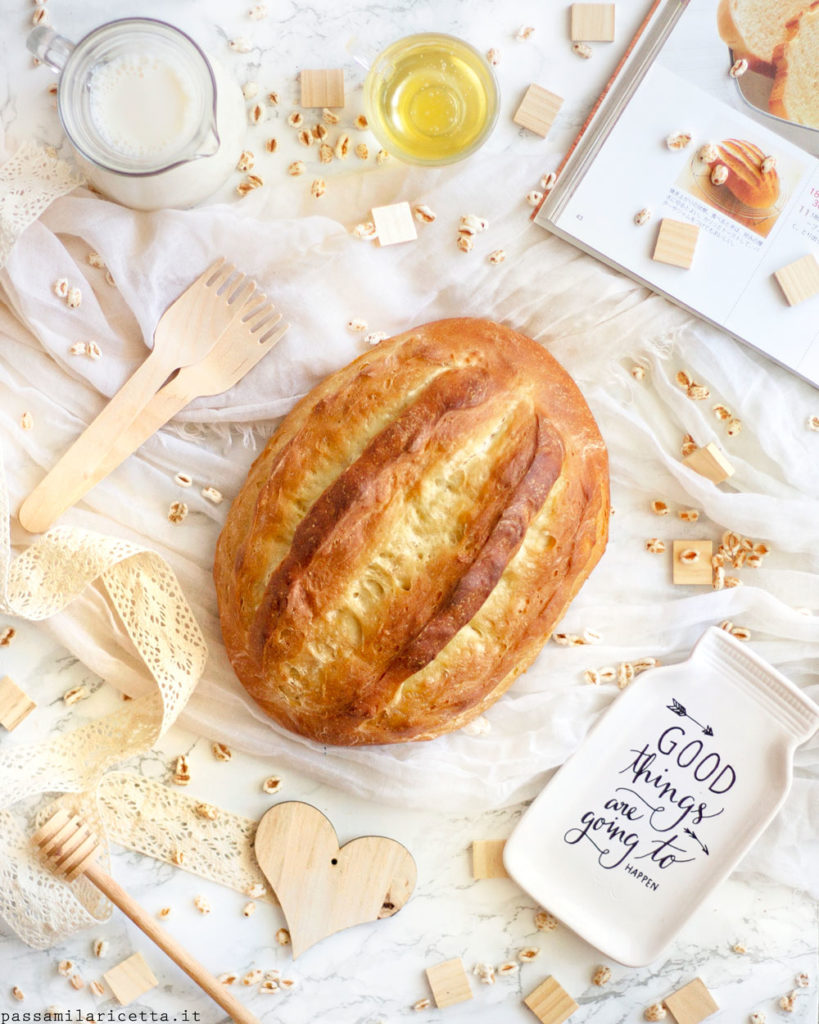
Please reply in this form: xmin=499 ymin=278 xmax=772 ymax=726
xmin=0 ymin=0 xmax=819 ymax=1024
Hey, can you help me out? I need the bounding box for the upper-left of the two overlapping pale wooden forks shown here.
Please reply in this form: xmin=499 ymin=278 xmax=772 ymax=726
xmin=17 ymin=259 xmax=256 ymax=534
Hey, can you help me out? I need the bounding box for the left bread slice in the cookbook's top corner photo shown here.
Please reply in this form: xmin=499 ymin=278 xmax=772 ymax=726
xmin=717 ymin=0 xmax=810 ymax=75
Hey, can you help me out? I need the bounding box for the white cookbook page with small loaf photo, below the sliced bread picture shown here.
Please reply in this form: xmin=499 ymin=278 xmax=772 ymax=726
xmin=554 ymin=0 xmax=819 ymax=383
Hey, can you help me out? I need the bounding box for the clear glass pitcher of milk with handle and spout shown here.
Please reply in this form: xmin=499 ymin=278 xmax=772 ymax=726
xmin=28 ymin=17 xmax=247 ymax=210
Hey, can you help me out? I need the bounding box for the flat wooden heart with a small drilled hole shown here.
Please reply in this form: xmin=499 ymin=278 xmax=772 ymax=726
xmin=254 ymin=801 xmax=416 ymax=958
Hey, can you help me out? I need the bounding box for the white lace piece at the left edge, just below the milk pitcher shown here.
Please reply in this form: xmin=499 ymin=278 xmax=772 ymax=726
xmin=0 ymin=142 xmax=82 ymax=267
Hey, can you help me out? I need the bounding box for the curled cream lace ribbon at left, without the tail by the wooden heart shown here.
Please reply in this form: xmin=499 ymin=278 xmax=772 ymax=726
xmin=0 ymin=448 xmax=207 ymax=948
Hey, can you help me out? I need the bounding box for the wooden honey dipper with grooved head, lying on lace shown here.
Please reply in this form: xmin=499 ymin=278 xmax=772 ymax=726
xmin=32 ymin=810 xmax=259 ymax=1024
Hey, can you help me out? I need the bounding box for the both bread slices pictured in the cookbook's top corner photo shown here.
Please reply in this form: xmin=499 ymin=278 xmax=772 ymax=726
xmin=717 ymin=0 xmax=819 ymax=129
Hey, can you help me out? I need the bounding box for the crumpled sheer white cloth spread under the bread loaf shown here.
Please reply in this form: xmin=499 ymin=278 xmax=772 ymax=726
xmin=0 ymin=142 xmax=819 ymax=895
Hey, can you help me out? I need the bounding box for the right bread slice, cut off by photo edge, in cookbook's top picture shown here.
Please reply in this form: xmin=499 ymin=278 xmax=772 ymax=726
xmin=769 ymin=0 xmax=819 ymax=128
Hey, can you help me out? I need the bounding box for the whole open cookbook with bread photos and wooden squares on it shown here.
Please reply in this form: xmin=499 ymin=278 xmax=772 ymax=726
xmin=534 ymin=0 xmax=819 ymax=386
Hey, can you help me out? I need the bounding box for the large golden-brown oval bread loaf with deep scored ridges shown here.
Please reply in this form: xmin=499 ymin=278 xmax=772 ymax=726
xmin=214 ymin=318 xmax=609 ymax=744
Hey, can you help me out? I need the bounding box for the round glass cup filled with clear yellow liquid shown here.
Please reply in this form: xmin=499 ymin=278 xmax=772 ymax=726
xmin=364 ymin=33 xmax=499 ymax=164
